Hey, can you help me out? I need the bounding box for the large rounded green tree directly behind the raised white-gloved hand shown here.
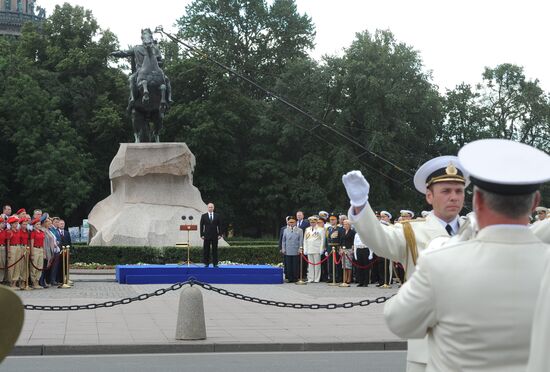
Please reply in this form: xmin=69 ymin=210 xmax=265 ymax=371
xmin=332 ymin=30 xmax=443 ymax=210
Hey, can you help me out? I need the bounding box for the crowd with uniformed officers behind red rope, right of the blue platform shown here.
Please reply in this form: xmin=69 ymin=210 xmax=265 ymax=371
xmin=279 ymin=210 xmax=414 ymax=287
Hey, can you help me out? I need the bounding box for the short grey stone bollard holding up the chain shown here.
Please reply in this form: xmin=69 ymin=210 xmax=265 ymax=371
xmin=176 ymin=287 xmax=206 ymax=340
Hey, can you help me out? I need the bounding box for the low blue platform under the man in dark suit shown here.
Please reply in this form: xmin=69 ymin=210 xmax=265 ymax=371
xmin=116 ymin=265 xmax=283 ymax=284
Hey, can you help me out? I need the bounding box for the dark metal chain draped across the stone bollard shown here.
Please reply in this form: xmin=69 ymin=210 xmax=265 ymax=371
xmin=24 ymin=279 xmax=395 ymax=311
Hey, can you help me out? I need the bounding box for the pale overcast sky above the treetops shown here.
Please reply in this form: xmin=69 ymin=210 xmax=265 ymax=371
xmin=37 ymin=0 xmax=550 ymax=91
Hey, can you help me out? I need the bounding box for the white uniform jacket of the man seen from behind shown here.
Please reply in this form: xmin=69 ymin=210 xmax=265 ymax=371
xmin=384 ymin=225 xmax=550 ymax=372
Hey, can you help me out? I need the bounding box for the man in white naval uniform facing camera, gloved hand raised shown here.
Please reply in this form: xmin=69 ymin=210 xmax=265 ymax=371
xmin=342 ymin=156 xmax=468 ymax=372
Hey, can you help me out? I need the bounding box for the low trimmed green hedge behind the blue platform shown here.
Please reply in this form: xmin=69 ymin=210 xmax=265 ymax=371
xmin=71 ymin=245 xmax=282 ymax=265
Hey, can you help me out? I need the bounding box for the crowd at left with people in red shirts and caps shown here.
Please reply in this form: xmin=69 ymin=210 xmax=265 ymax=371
xmin=0 ymin=205 xmax=71 ymax=290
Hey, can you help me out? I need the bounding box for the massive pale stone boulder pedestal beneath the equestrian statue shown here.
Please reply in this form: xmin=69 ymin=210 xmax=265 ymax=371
xmin=88 ymin=143 xmax=227 ymax=247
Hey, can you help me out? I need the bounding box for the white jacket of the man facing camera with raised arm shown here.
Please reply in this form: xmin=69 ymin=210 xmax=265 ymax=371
xmin=348 ymin=203 xmax=462 ymax=364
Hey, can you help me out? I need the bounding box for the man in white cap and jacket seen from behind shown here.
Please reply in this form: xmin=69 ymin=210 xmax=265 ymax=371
xmin=384 ymin=139 xmax=550 ymax=372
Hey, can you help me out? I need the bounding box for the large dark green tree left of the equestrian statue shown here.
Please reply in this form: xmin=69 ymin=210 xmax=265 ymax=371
xmin=0 ymin=3 xmax=130 ymax=220
